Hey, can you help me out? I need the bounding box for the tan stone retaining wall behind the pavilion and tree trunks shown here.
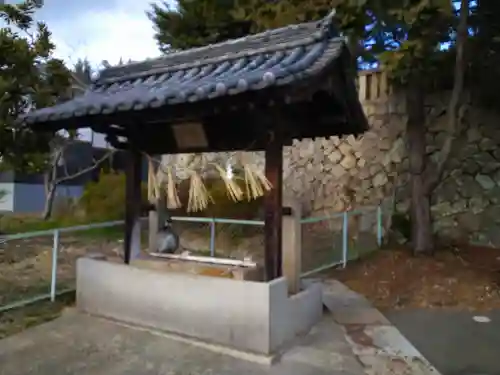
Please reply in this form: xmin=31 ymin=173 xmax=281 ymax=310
xmin=159 ymin=72 xmax=500 ymax=250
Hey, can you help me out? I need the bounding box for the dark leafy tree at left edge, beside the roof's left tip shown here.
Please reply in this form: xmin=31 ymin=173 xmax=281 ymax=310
xmin=0 ymin=1 xmax=70 ymax=169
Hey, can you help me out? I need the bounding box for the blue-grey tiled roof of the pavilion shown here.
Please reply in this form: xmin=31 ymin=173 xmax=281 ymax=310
xmin=22 ymin=14 xmax=345 ymax=124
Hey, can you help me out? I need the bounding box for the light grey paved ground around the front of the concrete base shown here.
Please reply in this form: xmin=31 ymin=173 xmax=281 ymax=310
xmin=0 ymin=281 xmax=439 ymax=375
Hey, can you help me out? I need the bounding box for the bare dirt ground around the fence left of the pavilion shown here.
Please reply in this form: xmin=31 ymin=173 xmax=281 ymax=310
xmin=0 ymin=235 xmax=122 ymax=339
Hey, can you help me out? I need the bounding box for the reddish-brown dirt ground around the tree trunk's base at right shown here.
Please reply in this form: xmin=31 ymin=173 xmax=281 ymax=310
xmin=327 ymin=246 xmax=500 ymax=310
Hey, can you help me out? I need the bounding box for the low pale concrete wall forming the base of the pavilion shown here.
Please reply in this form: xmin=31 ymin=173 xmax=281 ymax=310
xmin=77 ymin=258 xmax=323 ymax=356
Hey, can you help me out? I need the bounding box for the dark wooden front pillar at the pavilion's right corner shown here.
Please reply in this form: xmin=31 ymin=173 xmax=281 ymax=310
xmin=264 ymin=132 xmax=283 ymax=281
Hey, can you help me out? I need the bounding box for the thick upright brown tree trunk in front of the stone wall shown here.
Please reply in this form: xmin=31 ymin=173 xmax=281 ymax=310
xmin=406 ymin=83 xmax=434 ymax=254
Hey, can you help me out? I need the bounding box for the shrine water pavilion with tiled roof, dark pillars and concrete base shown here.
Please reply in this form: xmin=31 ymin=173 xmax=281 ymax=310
xmin=20 ymin=11 xmax=368 ymax=355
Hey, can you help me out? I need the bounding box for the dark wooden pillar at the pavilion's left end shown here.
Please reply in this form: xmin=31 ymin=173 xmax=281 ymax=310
xmin=124 ymin=150 xmax=142 ymax=264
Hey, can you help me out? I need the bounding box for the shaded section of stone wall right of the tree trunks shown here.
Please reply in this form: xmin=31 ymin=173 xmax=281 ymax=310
xmin=424 ymin=108 xmax=500 ymax=247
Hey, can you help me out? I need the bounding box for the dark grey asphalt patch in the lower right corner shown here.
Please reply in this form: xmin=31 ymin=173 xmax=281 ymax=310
xmin=386 ymin=309 xmax=500 ymax=375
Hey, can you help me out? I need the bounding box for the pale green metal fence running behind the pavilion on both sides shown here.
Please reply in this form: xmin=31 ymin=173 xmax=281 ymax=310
xmin=0 ymin=201 xmax=390 ymax=313
